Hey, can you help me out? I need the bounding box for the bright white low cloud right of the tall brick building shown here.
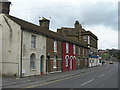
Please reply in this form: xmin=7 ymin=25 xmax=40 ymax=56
xmin=86 ymin=25 xmax=118 ymax=49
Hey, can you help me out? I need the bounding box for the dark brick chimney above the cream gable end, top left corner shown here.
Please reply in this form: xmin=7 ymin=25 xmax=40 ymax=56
xmin=0 ymin=0 xmax=11 ymax=15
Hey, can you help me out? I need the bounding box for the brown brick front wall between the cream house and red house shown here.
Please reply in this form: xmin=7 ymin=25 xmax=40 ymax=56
xmin=46 ymin=38 xmax=62 ymax=72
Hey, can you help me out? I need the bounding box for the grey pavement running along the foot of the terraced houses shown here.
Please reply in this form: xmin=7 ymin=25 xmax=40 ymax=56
xmin=0 ymin=65 xmax=106 ymax=87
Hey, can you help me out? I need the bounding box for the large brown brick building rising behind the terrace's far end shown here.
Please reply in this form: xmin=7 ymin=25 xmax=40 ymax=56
xmin=57 ymin=21 xmax=98 ymax=67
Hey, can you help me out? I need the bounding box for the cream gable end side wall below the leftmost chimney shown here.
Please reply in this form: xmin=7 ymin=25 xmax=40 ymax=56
xmin=0 ymin=14 xmax=21 ymax=76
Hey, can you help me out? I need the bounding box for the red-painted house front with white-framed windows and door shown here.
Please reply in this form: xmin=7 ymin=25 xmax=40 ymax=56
xmin=62 ymin=42 xmax=76 ymax=72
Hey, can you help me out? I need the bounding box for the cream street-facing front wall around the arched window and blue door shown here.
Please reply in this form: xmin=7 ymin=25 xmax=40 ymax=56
xmin=22 ymin=31 xmax=46 ymax=76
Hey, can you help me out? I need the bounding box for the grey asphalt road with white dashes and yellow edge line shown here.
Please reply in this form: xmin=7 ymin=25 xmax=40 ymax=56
xmin=1 ymin=63 xmax=118 ymax=88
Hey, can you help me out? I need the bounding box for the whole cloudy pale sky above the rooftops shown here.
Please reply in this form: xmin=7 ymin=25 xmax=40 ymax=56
xmin=9 ymin=0 xmax=119 ymax=49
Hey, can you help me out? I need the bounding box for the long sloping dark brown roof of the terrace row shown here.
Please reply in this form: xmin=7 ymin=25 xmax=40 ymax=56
xmin=5 ymin=14 xmax=89 ymax=49
